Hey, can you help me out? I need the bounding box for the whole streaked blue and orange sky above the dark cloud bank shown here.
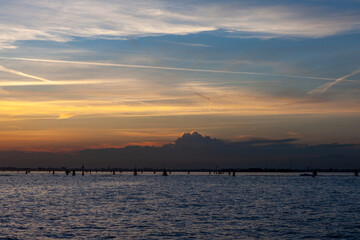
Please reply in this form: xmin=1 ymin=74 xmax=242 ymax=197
xmin=0 ymin=0 xmax=360 ymax=152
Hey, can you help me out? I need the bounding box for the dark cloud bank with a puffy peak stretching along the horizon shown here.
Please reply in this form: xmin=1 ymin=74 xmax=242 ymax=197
xmin=0 ymin=132 xmax=360 ymax=169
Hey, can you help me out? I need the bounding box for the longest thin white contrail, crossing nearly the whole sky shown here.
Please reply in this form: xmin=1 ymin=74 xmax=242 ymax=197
xmin=0 ymin=57 xmax=344 ymax=81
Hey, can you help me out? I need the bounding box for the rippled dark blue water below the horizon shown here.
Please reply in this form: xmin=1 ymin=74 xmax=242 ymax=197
xmin=0 ymin=173 xmax=360 ymax=239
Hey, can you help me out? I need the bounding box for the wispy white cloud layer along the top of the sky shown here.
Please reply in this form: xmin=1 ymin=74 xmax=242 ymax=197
xmin=0 ymin=0 xmax=360 ymax=48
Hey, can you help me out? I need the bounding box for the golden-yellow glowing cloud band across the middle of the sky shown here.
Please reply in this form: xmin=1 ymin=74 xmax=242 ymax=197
xmin=0 ymin=78 xmax=359 ymax=124
